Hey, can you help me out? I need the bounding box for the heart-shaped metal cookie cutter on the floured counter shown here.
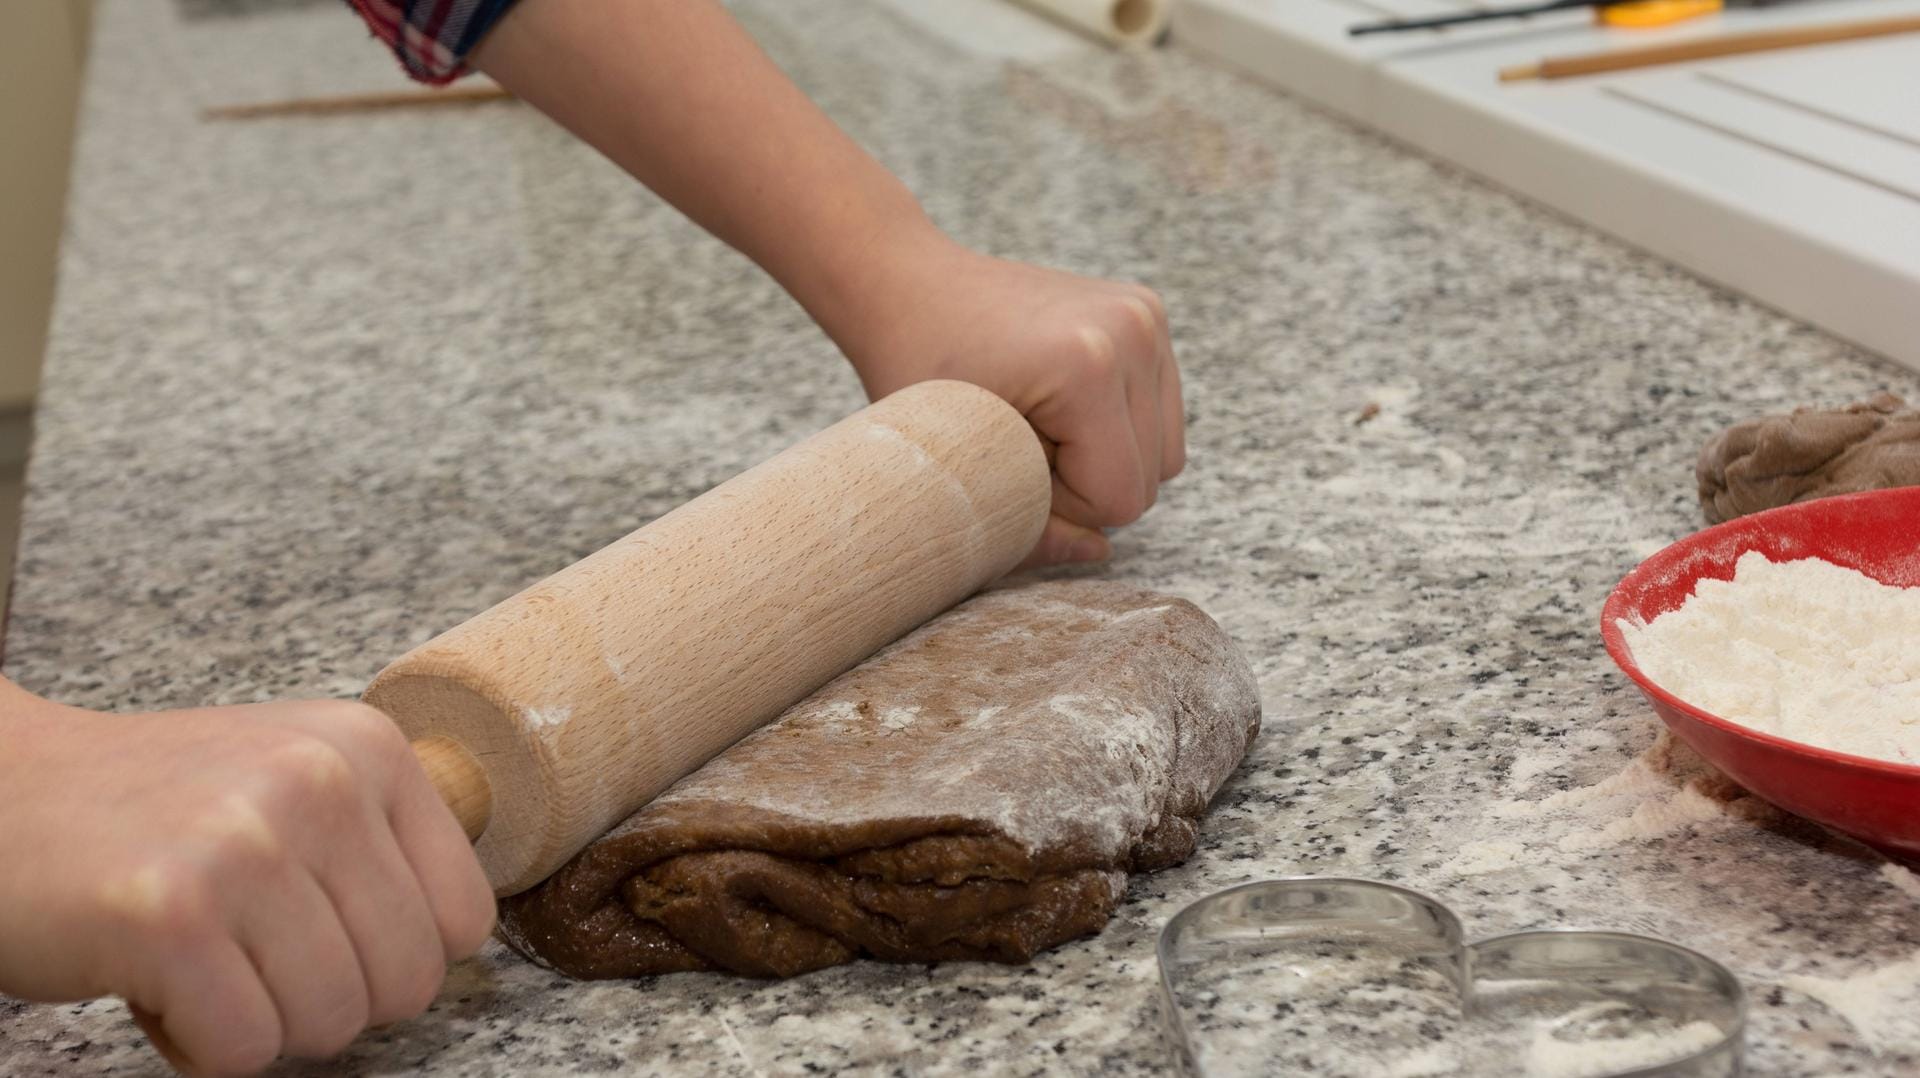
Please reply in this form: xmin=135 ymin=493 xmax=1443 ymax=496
xmin=1158 ymin=876 xmax=1747 ymax=1078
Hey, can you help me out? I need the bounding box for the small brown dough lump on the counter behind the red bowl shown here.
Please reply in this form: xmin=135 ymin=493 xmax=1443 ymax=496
xmin=1693 ymin=394 xmax=1920 ymax=525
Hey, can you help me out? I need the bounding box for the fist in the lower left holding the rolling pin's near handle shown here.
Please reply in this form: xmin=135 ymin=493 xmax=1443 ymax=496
xmin=0 ymin=682 xmax=493 ymax=1074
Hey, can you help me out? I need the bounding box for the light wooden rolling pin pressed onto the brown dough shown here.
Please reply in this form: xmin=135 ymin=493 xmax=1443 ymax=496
xmin=367 ymin=382 xmax=1052 ymax=895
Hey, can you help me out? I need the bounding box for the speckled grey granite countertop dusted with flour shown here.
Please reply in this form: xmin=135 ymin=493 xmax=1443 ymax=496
xmin=0 ymin=0 xmax=1920 ymax=1074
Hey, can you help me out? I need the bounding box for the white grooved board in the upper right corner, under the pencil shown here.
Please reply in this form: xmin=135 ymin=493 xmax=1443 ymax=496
xmin=1173 ymin=0 xmax=1920 ymax=369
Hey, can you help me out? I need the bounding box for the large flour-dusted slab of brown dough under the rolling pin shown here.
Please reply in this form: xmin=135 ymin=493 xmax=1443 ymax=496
xmin=501 ymin=582 xmax=1260 ymax=976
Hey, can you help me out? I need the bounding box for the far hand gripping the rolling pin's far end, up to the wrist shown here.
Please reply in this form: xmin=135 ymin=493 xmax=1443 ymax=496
xmin=829 ymin=240 xmax=1187 ymax=565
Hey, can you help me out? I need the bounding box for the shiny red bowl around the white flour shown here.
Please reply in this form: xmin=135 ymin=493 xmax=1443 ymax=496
xmin=1599 ymin=486 xmax=1920 ymax=863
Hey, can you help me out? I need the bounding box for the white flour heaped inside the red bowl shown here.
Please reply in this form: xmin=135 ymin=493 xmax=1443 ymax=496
xmin=1619 ymin=551 xmax=1920 ymax=765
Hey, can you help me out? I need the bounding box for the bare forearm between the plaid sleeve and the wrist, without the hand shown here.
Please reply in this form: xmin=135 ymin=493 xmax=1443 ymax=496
xmin=472 ymin=0 xmax=939 ymax=336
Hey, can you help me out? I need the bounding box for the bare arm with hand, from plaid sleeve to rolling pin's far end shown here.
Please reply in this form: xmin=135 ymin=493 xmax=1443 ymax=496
xmin=472 ymin=0 xmax=1185 ymax=561
